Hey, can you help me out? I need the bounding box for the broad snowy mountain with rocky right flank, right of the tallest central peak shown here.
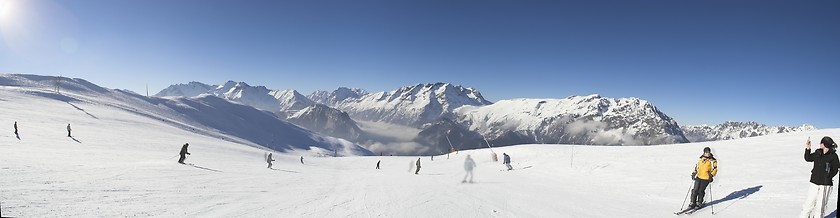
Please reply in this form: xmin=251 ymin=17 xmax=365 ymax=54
xmin=455 ymin=95 xmax=688 ymax=146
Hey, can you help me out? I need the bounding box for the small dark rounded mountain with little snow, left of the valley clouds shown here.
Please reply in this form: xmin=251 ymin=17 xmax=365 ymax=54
xmin=286 ymin=104 xmax=365 ymax=142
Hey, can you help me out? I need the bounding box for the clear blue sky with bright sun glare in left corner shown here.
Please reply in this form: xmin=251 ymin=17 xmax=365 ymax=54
xmin=0 ymin=0 xmax=840 ymax=128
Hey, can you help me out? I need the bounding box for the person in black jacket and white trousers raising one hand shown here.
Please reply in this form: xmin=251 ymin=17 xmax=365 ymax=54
xmin=799 ymin=136 xmax=840 ymax=218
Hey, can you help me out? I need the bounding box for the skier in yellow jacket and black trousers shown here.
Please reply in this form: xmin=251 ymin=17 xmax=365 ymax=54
xmin=688 ymin=147 xmax=717 ymax=208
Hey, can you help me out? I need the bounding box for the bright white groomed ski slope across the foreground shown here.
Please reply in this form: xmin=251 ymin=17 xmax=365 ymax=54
xmin=0 ymin=76 xmax=840 ymax=217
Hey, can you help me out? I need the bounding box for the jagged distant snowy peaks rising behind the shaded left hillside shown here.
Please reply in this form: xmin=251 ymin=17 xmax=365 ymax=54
xmin=155 ymin=81 xmax=315 ymax=114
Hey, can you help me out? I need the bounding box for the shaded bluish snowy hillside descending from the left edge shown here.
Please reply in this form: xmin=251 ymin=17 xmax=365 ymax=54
xmin=0 ymin=74 xmax=372 ymax=155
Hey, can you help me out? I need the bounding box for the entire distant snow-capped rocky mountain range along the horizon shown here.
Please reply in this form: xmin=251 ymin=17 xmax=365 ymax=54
xmin=156 ymin=81 xmax=816 ymax=152
